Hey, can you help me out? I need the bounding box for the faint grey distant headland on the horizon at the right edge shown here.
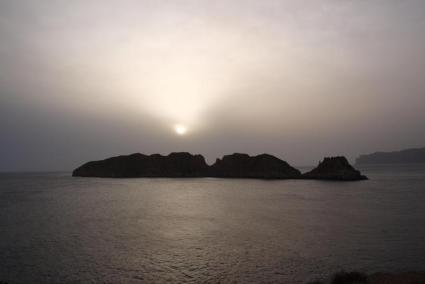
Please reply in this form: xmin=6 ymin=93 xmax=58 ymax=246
xmin=356 ymin=148 xmax=425 ymax=165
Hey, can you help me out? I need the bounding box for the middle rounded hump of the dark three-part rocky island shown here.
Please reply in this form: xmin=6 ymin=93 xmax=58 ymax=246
xmin=209 ymin=153 xmax=301 ymax=179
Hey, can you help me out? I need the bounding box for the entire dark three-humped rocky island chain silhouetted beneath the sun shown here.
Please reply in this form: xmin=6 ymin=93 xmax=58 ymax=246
xmin=72 ymin=153 xmax=366 ymax=180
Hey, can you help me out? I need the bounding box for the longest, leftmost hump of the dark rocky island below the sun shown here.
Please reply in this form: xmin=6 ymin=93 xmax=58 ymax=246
xmin=72 ymin=153 xmax=208 ymax=178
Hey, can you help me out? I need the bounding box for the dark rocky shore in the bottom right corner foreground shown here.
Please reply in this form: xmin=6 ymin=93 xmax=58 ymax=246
xmin=307 ymin=271 xmax=425 ymax=284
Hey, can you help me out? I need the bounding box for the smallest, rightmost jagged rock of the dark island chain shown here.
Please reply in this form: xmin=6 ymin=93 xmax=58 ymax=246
xmin=303 ymin=157 xmax=367 ymax=181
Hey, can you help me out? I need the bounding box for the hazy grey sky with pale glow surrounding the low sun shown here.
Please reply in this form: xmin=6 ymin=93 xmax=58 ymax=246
xmin=0 ymin=0 xmax=425 ymax=171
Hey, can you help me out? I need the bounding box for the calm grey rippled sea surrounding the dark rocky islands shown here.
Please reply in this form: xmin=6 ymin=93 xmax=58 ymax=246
xmin=0 ymin=165 xmax=425 ymax=283
